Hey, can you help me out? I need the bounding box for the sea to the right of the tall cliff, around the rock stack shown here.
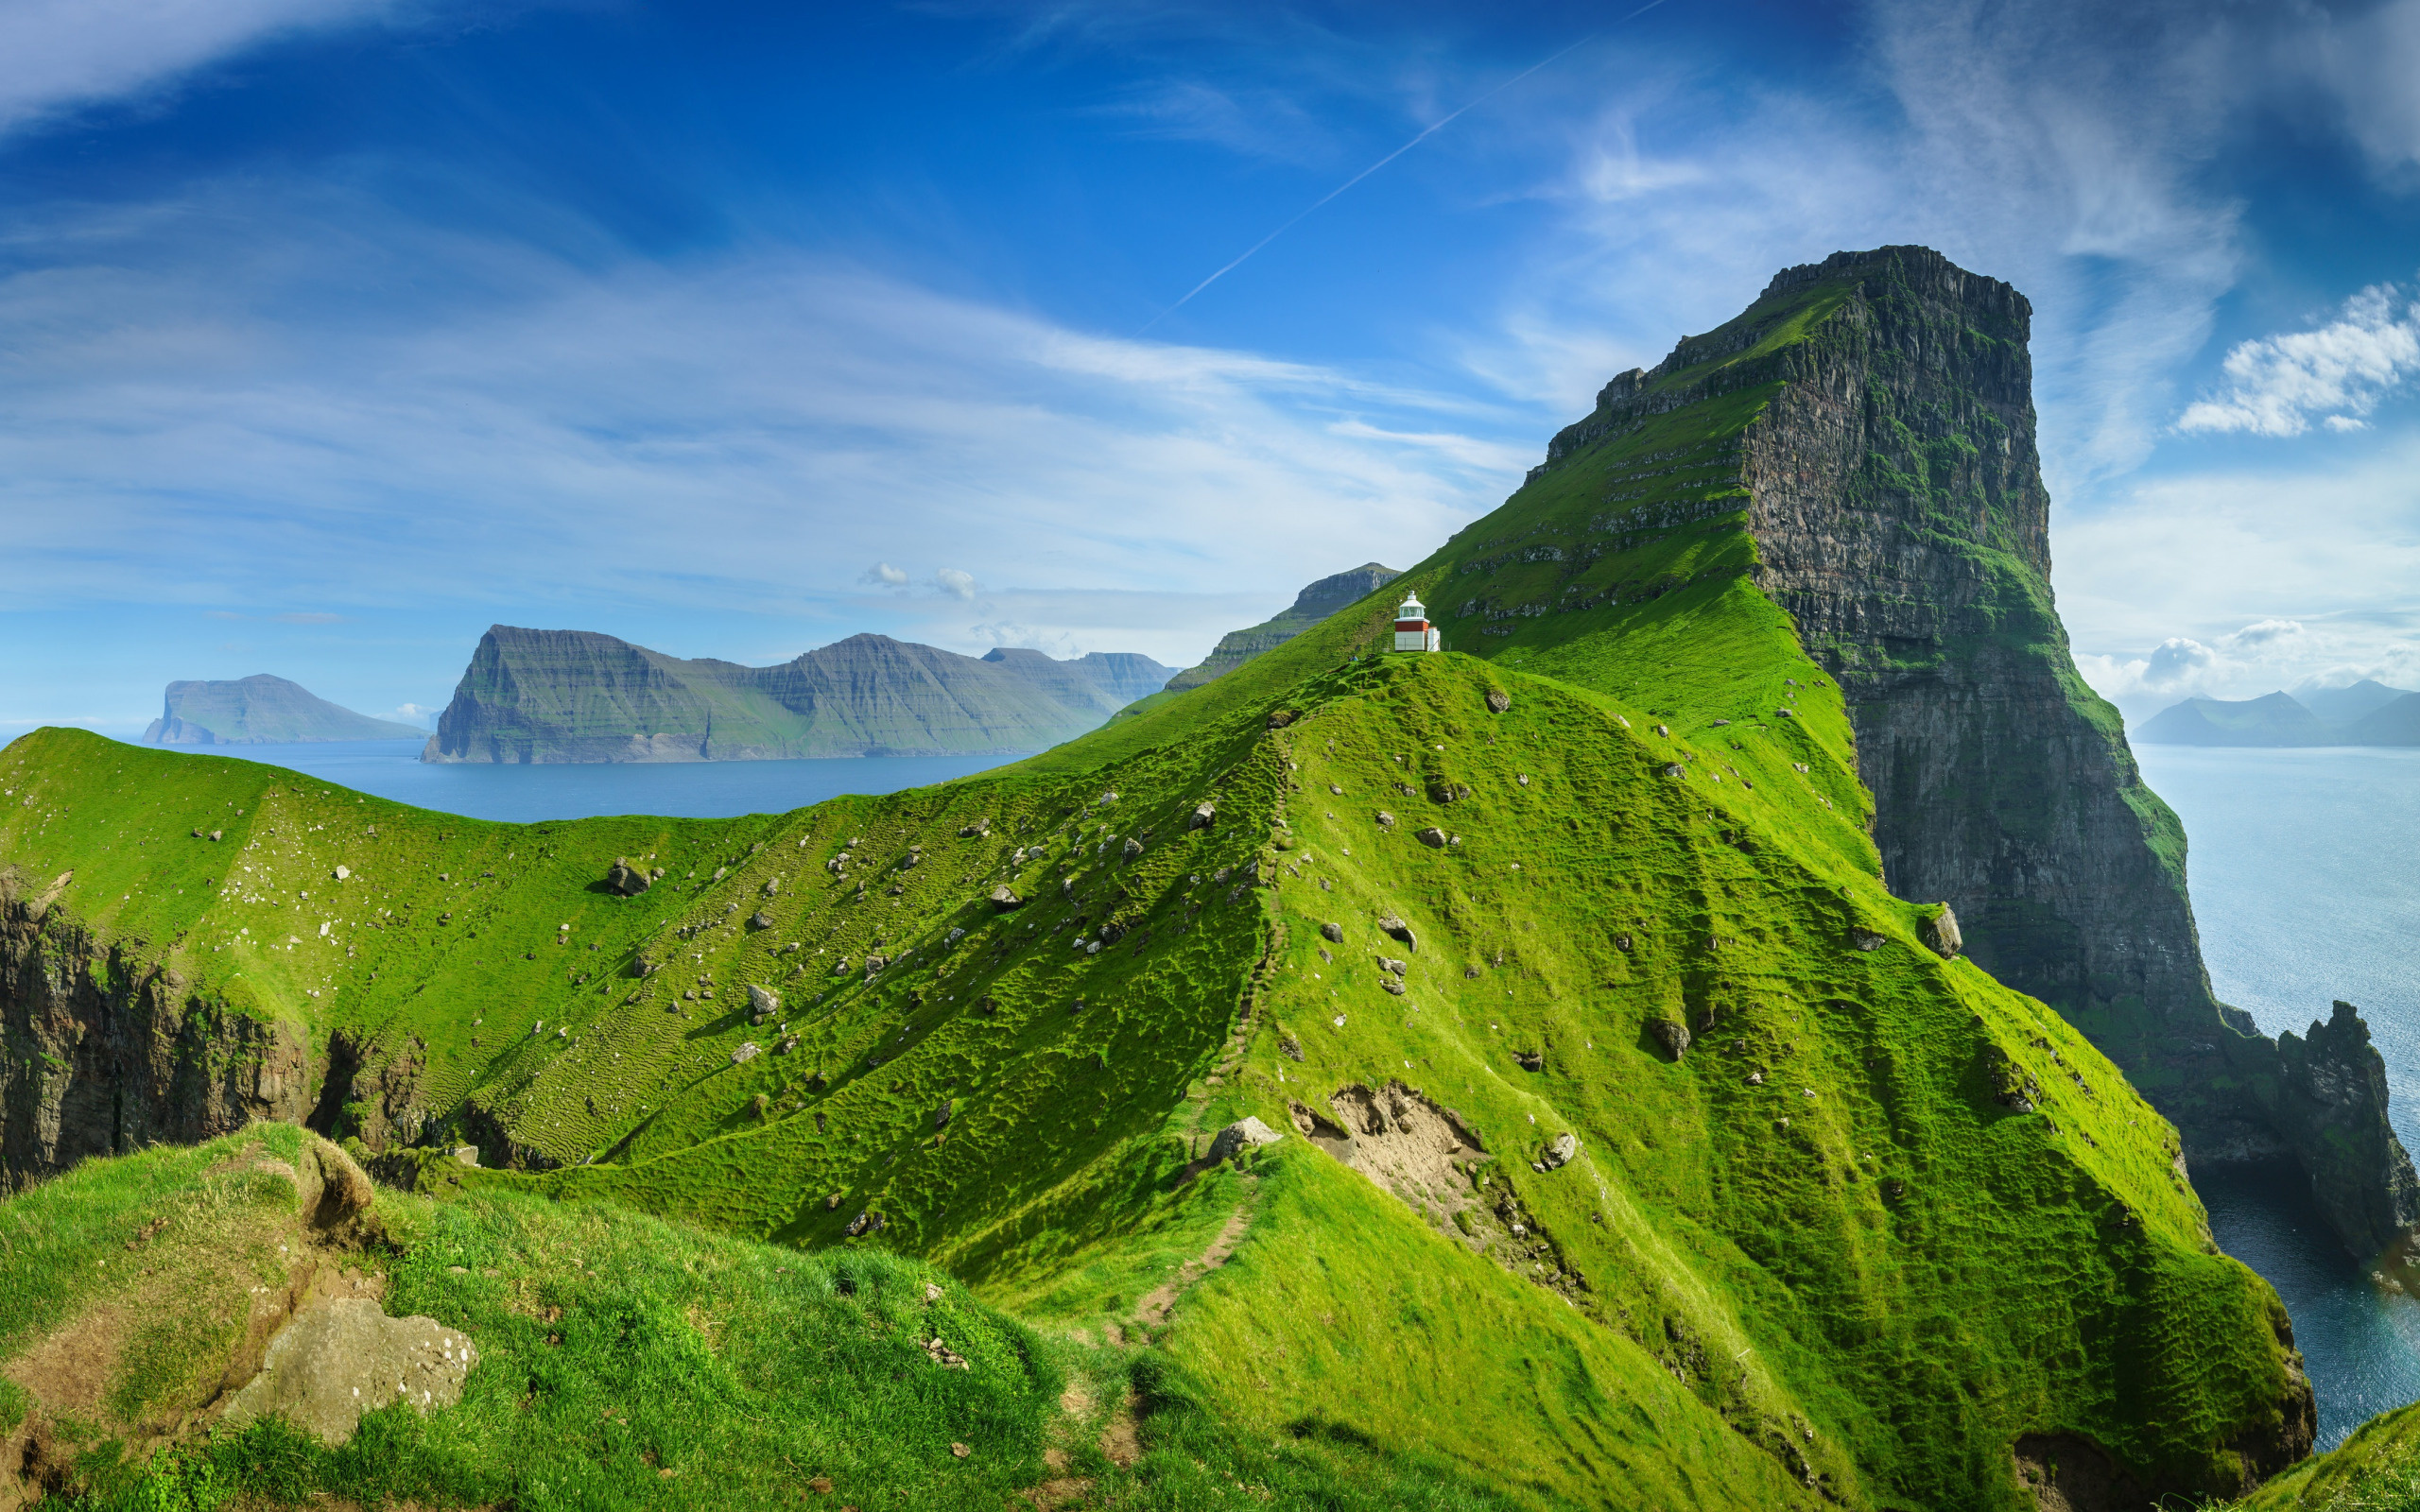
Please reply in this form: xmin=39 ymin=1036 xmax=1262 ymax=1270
xmin=2135 ymin=745 xmax=2420 ymax=1449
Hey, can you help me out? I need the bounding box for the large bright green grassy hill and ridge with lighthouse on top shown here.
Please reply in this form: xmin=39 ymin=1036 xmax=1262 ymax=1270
xmin=0 ymin=244 xmax=2342 ymax=1509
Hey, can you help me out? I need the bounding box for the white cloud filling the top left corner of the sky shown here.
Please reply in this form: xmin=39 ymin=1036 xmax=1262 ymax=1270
xmin=0 ymin=0 xmax=399 ymax=133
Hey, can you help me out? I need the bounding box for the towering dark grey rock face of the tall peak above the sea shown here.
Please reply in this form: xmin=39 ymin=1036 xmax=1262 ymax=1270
xmin=1684 ymin=247 xmax=2420 ymax=1258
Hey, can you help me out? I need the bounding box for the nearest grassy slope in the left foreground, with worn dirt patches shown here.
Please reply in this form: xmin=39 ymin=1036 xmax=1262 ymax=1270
xmin=0 ymin=1125 xmax=1503 ymax=1512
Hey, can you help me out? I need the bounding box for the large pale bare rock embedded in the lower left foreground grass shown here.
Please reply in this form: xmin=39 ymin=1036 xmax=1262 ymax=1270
xmin=223 ymin=1297 xmax=479 ymax=1444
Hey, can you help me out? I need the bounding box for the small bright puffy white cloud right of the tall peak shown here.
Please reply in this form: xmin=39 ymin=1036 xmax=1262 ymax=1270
xmin=2175 ymin=284 xmax=2420 ymax=436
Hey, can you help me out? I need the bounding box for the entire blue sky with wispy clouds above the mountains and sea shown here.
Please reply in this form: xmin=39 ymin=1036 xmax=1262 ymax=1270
xmin=0 ymin=0 xmax=2420 ymax=735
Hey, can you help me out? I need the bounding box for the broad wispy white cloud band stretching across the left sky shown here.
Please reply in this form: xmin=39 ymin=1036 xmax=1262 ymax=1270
xmin=0 ymin=186 xmax=1537 ymax=661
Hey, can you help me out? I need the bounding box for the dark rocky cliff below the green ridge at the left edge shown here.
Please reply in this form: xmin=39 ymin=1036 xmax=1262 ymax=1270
xmin=0 ymin=871 xmax=312 ymax=1193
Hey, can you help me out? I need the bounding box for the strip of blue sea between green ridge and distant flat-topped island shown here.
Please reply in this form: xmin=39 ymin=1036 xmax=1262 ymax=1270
xmin=139 ymin=740 xmax=1016 ymax=825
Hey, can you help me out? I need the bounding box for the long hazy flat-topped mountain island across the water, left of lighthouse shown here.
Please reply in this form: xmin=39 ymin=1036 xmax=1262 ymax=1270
xmin=421 ymin=624 xmax=1168 ymax=762
